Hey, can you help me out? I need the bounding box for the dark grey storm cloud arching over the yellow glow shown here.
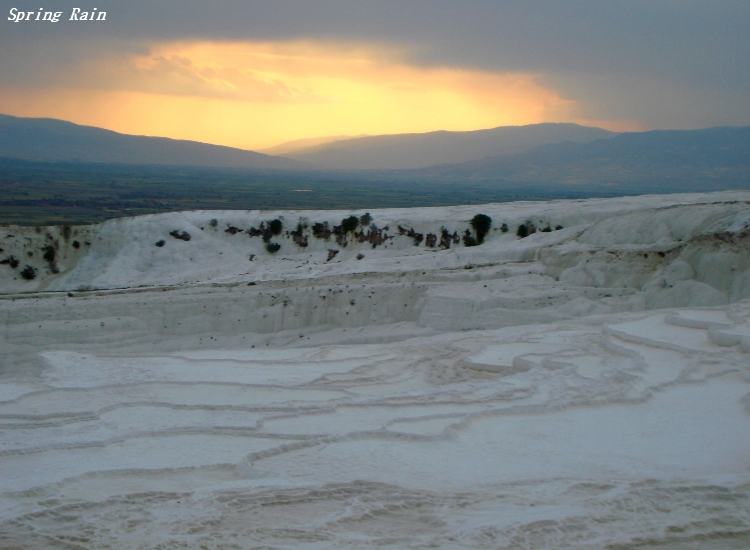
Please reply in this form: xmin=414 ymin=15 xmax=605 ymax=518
xmin=0 ymin=0 xmax=750 ymax=127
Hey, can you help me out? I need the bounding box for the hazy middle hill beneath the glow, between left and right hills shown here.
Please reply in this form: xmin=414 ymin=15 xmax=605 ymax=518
xmin=286 ymin=123 xmax=617 ymax=170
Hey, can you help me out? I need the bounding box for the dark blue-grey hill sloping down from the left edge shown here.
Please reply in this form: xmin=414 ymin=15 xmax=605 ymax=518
xmin=0 ymin=115 xmax=307 ymax=170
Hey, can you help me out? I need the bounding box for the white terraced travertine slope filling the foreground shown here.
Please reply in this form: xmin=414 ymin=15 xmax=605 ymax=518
xmin=0 ymin=192 xmax=750 ymax=550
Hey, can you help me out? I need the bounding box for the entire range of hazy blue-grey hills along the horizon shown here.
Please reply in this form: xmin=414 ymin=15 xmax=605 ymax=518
xmin=0 ymin=115 xmax=750 ymax=191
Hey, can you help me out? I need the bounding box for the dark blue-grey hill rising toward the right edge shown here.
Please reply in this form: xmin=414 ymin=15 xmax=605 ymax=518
xmin=412 ymin=126 xmax=750 ymax=189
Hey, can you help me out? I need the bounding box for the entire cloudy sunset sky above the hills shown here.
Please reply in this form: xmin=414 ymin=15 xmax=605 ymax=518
xmin=0 ymin=0 xmax=750 ymax=150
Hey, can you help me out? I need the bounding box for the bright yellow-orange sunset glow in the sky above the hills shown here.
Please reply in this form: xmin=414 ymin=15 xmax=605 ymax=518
xmin=0 ymin=42 xmax=575 ymax=149
